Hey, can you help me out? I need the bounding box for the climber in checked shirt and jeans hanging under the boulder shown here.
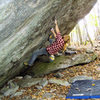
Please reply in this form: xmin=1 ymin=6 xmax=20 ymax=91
xmin=24 ymin=20 xmax=70 ymax=66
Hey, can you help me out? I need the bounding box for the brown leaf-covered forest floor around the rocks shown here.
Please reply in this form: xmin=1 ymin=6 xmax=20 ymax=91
xmin=3 ymin=41 xmax=100 ymax=100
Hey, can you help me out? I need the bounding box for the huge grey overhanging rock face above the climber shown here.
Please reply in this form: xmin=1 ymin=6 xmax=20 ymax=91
xmin=0 ymin=0 xmax=96 ymax=87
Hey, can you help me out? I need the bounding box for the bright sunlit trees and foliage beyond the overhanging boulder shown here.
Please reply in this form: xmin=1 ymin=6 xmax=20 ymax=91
xmin=70 ymin=3 xmax=100 ymax=45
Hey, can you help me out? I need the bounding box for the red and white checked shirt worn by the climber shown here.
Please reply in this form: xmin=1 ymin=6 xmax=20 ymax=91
xmin=46 ymin=33 xmax=64 ymax=55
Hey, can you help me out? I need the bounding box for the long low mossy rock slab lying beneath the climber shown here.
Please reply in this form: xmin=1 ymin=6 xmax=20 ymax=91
xmin=27 ymin=53 xmax=98 ymax=77
